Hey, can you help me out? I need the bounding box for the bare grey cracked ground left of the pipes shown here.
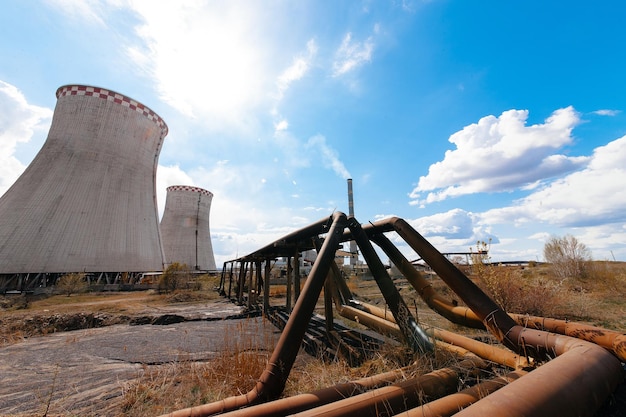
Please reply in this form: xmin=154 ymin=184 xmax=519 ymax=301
xmin=0 ymin=302 xmax=278 ymax=416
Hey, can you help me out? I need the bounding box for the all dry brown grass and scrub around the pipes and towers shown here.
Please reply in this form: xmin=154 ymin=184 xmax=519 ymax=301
xmin=0 ymin=262 xmax=626 ymax=416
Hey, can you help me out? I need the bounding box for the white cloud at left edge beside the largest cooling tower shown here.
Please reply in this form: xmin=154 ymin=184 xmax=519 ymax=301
xmin=0 ymin=80 xmax=52 ymax=195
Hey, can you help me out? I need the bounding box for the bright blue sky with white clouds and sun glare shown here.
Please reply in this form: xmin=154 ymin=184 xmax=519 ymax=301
xmin=0 ymin=0 xmax=626 ymax=268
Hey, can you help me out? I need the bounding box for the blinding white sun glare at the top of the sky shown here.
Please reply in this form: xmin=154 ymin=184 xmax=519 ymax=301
xmin=129 ymin=3 xmax=267 ymax=127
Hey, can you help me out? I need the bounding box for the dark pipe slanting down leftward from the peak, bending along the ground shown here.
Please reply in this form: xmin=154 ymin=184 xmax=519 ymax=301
xmin=161 ymin=212 xmax=347 ymax=417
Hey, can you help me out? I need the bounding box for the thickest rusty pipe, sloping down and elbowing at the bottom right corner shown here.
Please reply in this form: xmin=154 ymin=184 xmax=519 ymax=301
xmin=364 ymin=218 xmax=622 ymax=416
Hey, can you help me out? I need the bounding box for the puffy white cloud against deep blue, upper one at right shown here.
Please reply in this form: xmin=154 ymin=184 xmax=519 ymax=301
xmin=410 ymin=107 xmax=588 ymax=205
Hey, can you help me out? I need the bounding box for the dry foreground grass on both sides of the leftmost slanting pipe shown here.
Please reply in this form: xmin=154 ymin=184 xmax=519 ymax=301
xmin=120 ymin=319 xmax=458 ymax=417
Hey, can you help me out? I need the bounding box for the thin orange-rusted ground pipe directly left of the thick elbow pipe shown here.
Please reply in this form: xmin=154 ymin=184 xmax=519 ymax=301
xmin=396 ymin=370 xmax=528 ymax=417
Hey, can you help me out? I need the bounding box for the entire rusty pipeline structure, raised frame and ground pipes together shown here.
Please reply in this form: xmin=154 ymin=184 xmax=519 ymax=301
xmin=163 ymin=212 xmax=626 ymax=417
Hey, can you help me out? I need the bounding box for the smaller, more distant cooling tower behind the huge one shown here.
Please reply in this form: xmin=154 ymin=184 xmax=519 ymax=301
xmin=161 ymin=185 xmax=216 ymax=271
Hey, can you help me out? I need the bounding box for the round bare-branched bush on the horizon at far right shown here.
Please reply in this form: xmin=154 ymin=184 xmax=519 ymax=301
xmin=543 ymin=235 xmax=591 ymax=279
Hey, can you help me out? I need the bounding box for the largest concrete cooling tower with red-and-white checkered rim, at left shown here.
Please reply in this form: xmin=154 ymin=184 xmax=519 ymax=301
xmin=0 ymin=85 xmax=167 ymax=273
